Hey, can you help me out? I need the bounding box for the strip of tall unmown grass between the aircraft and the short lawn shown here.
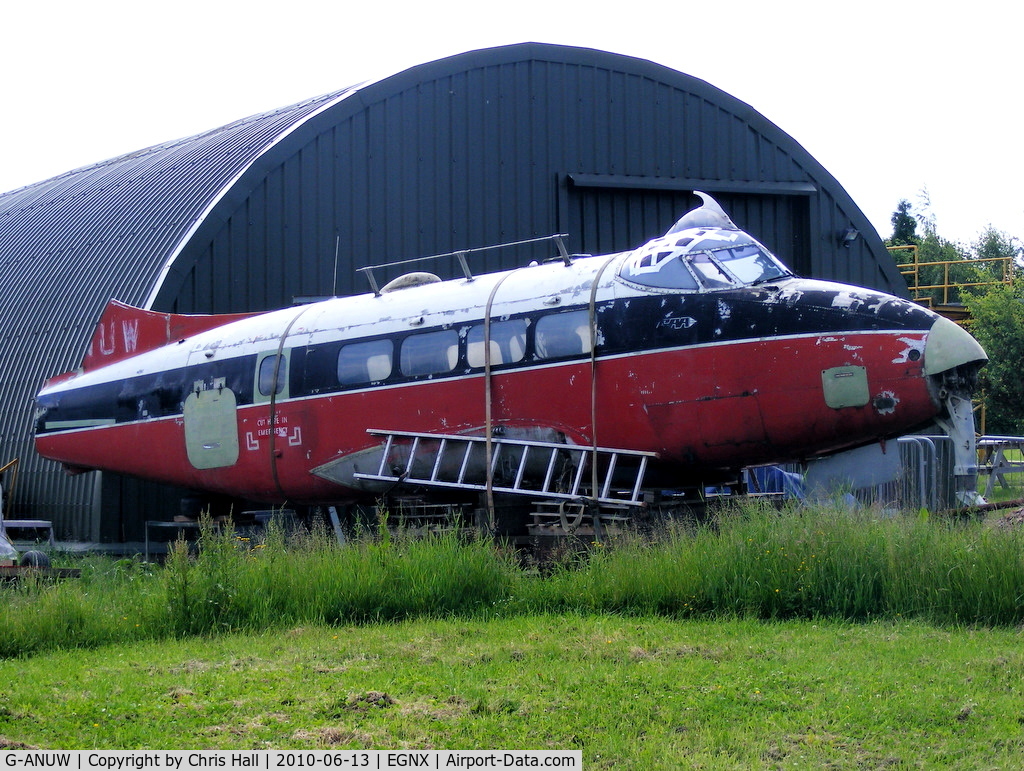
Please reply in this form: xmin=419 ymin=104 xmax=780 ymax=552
xmin=0 ymin=505 xmax=1024 ymax=656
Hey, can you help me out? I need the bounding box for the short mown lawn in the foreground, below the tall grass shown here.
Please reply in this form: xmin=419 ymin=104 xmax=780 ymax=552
xmin=0 ymin=613 xmax=1024 ymax=769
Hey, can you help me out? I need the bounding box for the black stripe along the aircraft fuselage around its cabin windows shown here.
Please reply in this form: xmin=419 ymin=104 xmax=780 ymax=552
xmin=36 ymin=287 xmax=934 ymax=434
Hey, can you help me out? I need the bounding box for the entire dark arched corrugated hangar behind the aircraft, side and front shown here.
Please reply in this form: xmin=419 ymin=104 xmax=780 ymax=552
xmin=0 ymin=44 xmax=903 ymax=540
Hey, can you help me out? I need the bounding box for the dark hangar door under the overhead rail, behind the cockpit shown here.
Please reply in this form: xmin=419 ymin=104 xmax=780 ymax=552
xmin=559 ymin=175 xmax=811 ymax=275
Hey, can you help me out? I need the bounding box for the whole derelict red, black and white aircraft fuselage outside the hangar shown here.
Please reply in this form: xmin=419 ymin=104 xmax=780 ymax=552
xmin=36 ymin=194 xmax=986 ymax=528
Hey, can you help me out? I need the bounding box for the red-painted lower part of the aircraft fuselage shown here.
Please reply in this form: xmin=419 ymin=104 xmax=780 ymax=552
xmin=36 ymin=331 xmax=938 ymax=503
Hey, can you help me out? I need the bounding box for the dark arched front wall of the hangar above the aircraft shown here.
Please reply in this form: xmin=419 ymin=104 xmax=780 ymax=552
xmin=156 ymin=44 xmax=900 ymax=312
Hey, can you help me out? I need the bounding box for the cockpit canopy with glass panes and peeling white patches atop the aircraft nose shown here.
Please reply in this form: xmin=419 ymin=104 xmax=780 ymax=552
xmin=618 ymin=228 xmax=790 ymax=292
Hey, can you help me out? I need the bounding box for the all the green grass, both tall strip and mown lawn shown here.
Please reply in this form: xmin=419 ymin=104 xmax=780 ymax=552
xmin=6 ymin=506 xmax=1024 ymax=769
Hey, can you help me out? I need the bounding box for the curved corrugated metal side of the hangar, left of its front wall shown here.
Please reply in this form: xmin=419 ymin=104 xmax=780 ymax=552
xmin=0 ymin=94 xmax=356 ymax=541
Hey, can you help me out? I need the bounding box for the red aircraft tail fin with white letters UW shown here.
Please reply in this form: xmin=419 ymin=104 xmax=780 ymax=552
xmin=80 ymin=300 xmax=256 ymax=372
